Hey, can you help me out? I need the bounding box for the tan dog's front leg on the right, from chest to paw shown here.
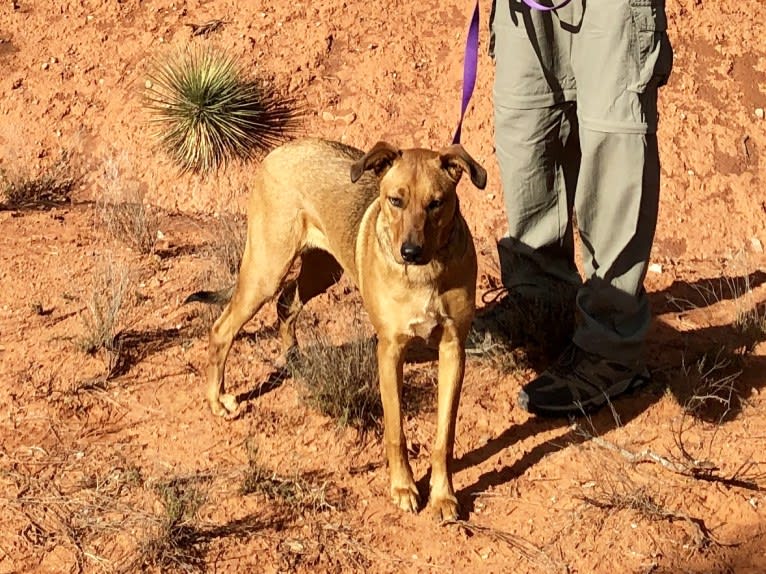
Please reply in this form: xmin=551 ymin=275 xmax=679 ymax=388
xmin=429 ymin=325 xmax=465 ymax=520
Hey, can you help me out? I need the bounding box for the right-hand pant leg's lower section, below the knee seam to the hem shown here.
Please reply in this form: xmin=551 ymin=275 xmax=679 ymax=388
xmin=574 ymin=130 xmax=660 ymax=369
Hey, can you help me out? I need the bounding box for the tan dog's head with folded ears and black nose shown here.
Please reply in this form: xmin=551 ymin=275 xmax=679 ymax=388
xmin=351 ymin=142 xmax=487 ymax=265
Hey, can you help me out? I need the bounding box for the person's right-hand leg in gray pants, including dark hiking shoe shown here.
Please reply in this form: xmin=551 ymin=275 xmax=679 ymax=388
xmin=519 ymin=0 xmax=672 ymax=414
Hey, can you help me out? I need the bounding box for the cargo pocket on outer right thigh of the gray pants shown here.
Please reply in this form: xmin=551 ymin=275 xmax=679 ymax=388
xmin=628 ymin=0 xmax=673 ymax=93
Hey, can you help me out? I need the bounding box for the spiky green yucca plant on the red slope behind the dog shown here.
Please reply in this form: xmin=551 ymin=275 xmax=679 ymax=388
xmin=146 ymin=47 xmax=299 ymax=173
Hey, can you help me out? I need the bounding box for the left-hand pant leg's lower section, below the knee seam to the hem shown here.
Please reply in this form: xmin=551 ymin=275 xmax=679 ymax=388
xmin=495 ymin=99 xmax=580 ymax=297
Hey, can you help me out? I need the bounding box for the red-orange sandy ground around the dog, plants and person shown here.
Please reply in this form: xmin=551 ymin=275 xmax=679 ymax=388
xmin=0 ymin=0 xmax=766 ymax=574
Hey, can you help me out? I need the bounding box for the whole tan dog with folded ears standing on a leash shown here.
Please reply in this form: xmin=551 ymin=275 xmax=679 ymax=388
xmin=188 ymin=140 xmax=487 ymax=519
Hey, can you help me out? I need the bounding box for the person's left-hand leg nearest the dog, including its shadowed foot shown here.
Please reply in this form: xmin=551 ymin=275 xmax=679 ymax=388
xmin=477 ymin=0 xmax=580 ymax=352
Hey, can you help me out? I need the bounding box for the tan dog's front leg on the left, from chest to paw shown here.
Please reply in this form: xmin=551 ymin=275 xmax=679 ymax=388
xmin=378 ymin=337 xmax=418 ymax=512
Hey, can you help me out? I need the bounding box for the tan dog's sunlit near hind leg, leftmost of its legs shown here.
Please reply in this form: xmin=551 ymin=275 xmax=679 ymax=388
xmin=206 ymin=233 xmax=300 ymax=416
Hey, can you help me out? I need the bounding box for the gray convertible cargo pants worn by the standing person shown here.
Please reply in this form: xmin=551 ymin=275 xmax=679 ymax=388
xmin=490 ymin=0 xmax=672 ymax=365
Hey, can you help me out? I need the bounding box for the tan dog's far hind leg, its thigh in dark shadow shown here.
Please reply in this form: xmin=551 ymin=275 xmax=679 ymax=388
xmin=277 ymin=249 xmax=343 ymax=361
